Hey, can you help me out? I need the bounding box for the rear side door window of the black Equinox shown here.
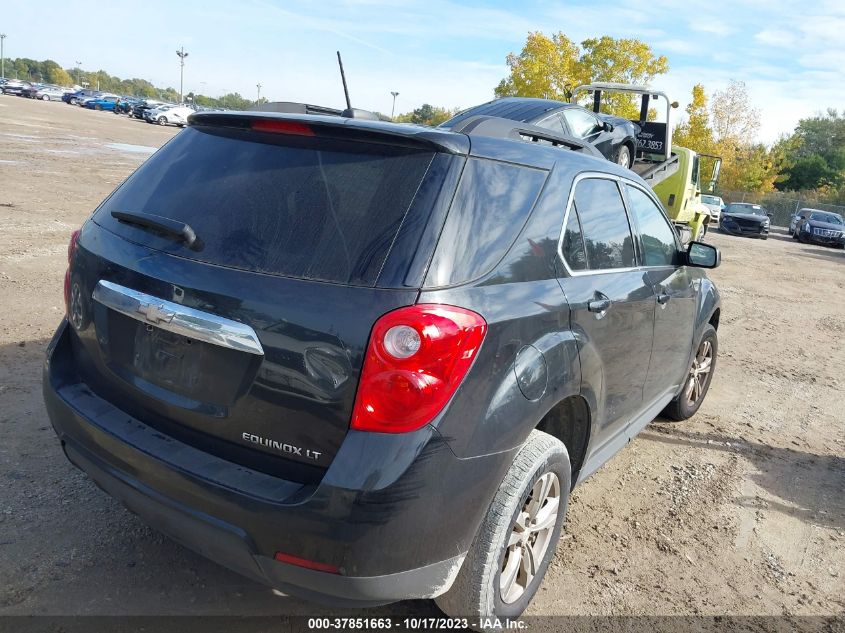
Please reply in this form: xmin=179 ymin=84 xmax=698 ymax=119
xmin=575 ymin=178 xmax=635 ymax=270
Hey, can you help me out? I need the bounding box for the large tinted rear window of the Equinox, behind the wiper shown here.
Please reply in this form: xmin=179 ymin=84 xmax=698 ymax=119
xmin=94 ymin=128 xmax=434 ymax=285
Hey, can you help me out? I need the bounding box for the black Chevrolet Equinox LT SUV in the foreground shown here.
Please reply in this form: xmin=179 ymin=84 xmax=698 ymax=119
xmin=44 ymin=112 xmax=720 ymax=626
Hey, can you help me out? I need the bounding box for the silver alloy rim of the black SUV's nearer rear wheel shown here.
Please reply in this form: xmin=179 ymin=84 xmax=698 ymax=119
xmin=499 ymin=472 xmax=561 ymax=604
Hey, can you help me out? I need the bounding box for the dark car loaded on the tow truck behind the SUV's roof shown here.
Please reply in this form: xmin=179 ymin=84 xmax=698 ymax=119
xmin=439 ymin=97 xmax=640 ymax=167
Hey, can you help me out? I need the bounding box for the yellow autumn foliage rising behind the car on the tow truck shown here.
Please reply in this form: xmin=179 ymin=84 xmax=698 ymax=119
xmin=494 ymin=32 xmax=669 ymax=119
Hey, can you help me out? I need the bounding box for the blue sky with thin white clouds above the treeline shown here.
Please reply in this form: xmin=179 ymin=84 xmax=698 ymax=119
xmin=0 ymin=0 xmax=845 ymax=142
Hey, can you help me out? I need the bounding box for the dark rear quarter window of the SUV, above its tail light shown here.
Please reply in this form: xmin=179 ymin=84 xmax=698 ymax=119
xmin=426 ymin=158 xmax=546 ymax=287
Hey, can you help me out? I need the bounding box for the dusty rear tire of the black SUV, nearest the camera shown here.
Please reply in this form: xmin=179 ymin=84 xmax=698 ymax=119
xmin=434 ymin=430 xmax=572 ymax=619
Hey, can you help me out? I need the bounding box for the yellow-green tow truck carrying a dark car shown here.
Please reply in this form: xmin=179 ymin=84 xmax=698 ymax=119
xmin=571 ymin=83 xmax=722 ymax=243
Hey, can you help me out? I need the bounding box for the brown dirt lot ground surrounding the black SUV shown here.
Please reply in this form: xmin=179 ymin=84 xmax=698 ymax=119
xmin=0 ymin=96 xmax=845 ymax=616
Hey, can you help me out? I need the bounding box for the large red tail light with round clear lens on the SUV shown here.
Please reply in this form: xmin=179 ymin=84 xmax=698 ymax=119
xmin=352 ymin=304 xmax=487 ymax=433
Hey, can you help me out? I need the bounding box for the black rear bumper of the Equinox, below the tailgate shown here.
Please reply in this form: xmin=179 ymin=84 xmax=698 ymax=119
xmin=43 ymin=322 xmax=513 ymax=606
